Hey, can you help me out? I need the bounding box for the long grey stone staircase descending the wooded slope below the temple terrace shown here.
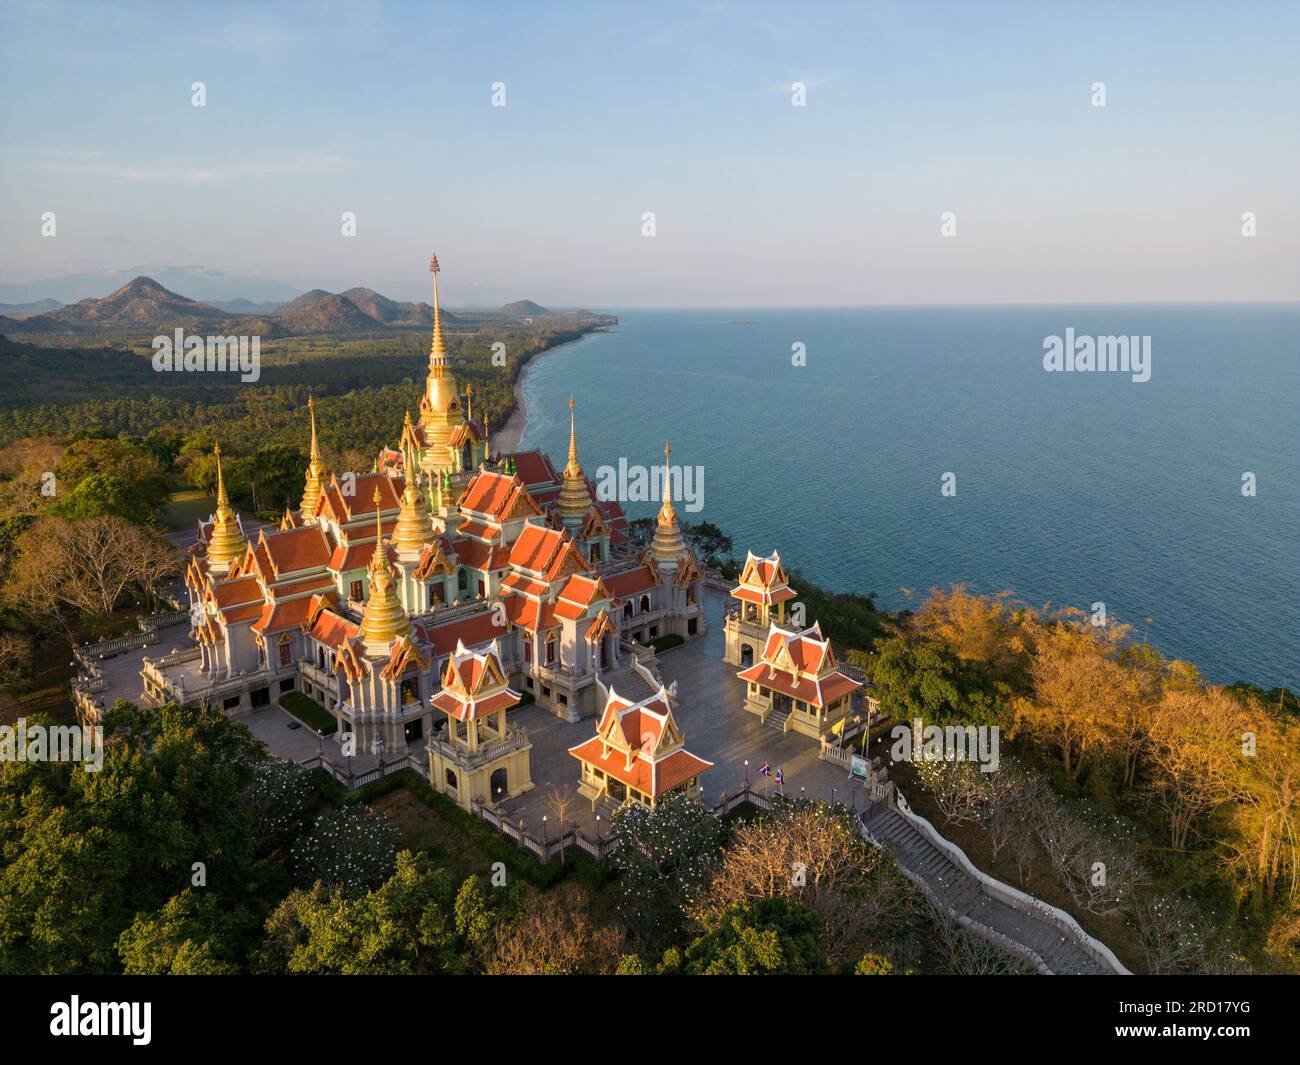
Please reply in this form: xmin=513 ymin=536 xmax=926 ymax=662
xmin=861 ymin=802 xmax=1113 ymax=975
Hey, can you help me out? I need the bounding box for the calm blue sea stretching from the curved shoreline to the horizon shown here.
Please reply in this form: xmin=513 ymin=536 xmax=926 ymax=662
xmin=521 ymin=304 xmax=1300 ymax=688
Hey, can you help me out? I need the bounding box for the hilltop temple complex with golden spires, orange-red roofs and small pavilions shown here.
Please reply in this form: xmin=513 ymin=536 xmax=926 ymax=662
xmin=143 ymin=257 xmax=862 ymax=809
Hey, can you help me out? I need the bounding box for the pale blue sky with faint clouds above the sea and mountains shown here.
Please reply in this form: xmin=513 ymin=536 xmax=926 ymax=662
xmin=0 ymin=3 xmax=1300 ymax=308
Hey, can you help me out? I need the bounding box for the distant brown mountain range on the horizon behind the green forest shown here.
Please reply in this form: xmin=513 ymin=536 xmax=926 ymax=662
xmin=0 ymin=276 xmax=613 ymax=338
